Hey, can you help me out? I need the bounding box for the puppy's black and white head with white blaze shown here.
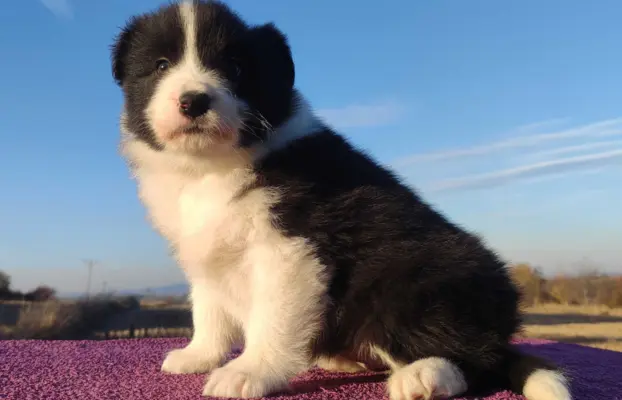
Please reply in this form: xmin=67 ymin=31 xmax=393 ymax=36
xmin=112 ymin=1 xmax=294 ymax=154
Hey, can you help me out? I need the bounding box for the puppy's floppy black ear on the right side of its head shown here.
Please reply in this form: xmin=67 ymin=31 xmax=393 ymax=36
xmin=247 ymin=23 xmax=296 ymax=92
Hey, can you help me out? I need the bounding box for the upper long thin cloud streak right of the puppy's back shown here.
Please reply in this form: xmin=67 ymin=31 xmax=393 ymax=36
xmin=394 ymin=118 xmax=622 ymax=166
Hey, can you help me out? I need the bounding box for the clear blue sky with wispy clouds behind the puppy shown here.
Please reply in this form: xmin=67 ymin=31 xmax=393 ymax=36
xmin=0 ymin=0 xmax=622 ymax=291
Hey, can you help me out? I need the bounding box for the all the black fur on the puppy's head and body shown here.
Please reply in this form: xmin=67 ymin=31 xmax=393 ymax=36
xmin=112 ymin=1 xmax=572 ymax=392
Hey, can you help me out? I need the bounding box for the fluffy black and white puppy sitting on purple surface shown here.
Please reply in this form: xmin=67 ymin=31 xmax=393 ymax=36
xmin=112 ymin=1 xmax=570 ymax=400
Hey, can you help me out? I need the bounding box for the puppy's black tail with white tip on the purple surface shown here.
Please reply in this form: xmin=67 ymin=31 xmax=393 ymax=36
xmin=504 ymin=346 xmax=572 ymax=400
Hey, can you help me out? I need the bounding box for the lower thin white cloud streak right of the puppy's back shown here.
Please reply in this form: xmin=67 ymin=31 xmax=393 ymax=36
xmin=430 ymin=148 xmax=622 ymax=192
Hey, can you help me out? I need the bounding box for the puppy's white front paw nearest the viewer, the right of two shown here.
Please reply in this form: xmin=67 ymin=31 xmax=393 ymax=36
xmin=203 ymin=356 xmax=287 ymax=399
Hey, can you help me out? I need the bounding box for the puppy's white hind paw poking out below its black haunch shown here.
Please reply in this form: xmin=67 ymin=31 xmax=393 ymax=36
xmin=387 ymin=357 xmax=467 ymax=400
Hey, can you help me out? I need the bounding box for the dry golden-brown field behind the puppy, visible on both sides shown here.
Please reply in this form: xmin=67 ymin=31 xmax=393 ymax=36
xmin=0 ymin=300 xmax=622 ymax=351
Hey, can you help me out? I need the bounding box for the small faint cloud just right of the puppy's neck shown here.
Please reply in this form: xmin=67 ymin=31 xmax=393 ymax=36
xmin=317 ymin=101 xmax=404 ymax=129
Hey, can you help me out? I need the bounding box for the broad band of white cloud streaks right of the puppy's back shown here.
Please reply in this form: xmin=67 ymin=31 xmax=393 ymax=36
xmin=394 ymin=118 xmax=622 ymax=193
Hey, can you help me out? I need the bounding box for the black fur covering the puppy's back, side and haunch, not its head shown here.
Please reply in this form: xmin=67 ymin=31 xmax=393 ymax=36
xmin=255 ymin=129 xmax=554 ymax=393
